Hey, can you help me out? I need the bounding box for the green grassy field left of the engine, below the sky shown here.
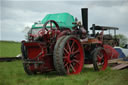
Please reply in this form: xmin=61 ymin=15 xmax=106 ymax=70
xmin=0 ymin=41 xmax=21 ymax=57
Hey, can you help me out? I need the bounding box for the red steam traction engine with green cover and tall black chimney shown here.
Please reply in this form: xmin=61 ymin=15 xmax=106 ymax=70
xmin=21 ymin=8 xmax=115 ymax=75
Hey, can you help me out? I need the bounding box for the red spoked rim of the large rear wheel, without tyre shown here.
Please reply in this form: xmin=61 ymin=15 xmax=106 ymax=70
xmin=63 ymin=38 xmax=84 ymax=74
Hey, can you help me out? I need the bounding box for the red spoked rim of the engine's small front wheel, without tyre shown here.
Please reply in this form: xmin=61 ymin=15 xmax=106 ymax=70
xmin=96 ymin=49 xmax=107 ymax=70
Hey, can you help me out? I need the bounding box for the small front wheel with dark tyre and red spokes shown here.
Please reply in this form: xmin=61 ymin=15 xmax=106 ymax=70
xmin=92 ymin=47 xmax=108 ymax=71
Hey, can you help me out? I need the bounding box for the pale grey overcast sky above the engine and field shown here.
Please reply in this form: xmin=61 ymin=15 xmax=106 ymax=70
xmin=0 ymin=0 xmax=128 ymax=41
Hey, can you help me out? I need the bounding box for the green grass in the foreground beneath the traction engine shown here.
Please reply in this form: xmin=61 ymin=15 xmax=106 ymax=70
xmin=0 ymin=61 xmax=128 ymax=85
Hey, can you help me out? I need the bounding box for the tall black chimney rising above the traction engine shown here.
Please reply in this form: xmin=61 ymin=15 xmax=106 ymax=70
xmin=81 ymin=8 xmax=88 ymax=32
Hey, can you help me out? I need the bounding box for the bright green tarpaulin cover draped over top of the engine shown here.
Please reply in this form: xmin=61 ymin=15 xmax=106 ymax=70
xmin=32 ymin=13 xmax=75 ymax=30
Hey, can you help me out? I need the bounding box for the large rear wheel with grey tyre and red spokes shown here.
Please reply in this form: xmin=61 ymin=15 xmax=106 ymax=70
xmin=53 ymin=36 xmax=84 ymax=75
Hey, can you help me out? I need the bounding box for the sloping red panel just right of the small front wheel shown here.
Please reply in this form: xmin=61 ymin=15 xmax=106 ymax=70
xmin=103 ymin=45 xmax=119 ymax=59
